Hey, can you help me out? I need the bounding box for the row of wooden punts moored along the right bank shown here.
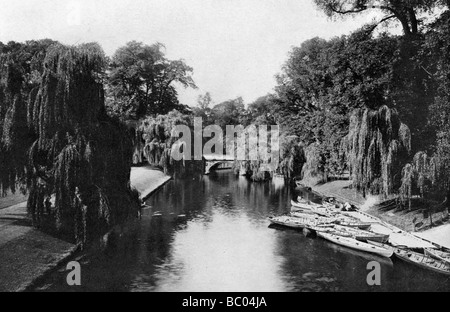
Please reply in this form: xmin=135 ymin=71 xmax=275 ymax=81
xmin=269 ymin=197 xmax=450 ymax=275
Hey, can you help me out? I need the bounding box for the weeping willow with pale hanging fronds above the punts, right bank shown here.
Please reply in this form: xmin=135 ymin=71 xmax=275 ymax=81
xmin=343 ymin=105 xmax=411 ymax=196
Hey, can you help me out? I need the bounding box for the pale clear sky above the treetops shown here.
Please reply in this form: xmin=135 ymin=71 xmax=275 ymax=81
xmin=0 ymin=0 xmax=380 ymax=106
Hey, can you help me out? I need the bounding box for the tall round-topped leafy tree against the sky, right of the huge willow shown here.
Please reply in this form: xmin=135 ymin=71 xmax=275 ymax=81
xmin=107 ymin=41 xmax=196 ymax=119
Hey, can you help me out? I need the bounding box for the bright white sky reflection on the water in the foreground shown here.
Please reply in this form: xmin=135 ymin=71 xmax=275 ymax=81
xmin=149 ymin=211 xmax=284 ymax=291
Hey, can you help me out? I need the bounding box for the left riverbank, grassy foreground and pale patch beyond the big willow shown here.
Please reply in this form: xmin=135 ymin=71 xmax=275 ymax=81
xmin=0 ymin=167 xmax=171 ymax=292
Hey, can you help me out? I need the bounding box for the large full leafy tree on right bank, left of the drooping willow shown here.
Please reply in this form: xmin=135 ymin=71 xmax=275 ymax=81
xmin=276 ymin=28 xmax=398 ymax=181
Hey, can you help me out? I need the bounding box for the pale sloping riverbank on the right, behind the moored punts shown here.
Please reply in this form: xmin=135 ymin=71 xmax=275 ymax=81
xmin=305 ymin=180 xmax=450 ymax=248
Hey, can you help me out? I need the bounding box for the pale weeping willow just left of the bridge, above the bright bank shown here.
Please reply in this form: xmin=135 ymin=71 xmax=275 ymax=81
xmin=135 ymin=110 xmax=205 ymax=177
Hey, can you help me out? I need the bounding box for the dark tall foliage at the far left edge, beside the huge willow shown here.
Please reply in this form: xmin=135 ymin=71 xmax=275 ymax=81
xmin=0 ymin=40 xmax=59 ymax=194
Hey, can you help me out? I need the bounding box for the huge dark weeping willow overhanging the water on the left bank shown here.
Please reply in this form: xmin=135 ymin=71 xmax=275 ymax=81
xmin=2 ymin=44 xmax=139 ymax=244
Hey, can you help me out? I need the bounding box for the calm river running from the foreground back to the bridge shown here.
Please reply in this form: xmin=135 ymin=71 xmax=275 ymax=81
xmin=35 ymin=171 xmax=450 ymax=292
